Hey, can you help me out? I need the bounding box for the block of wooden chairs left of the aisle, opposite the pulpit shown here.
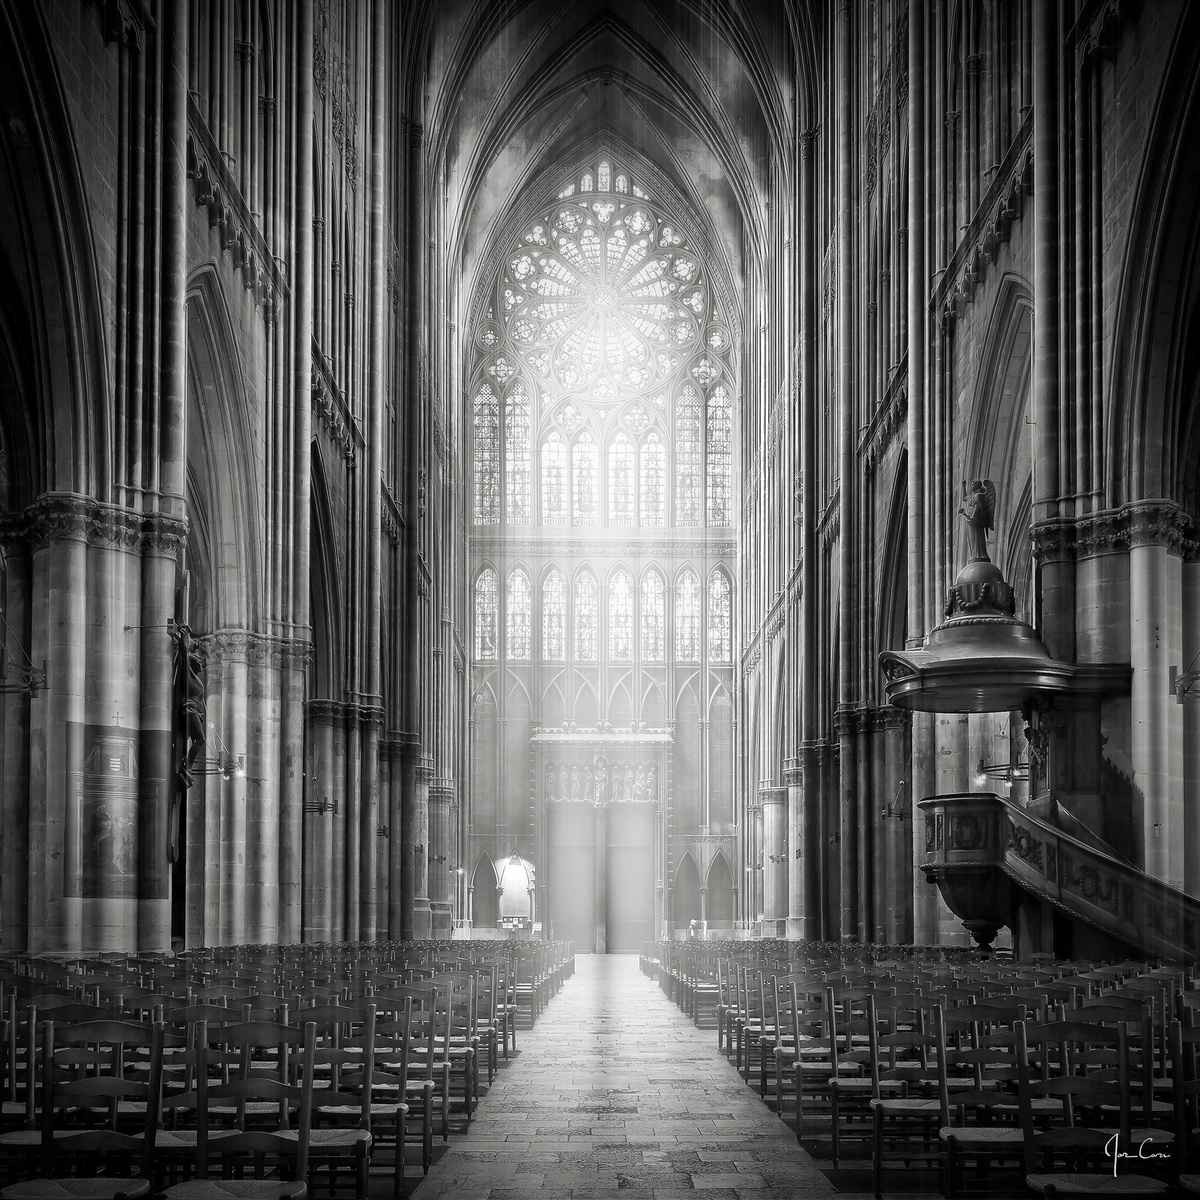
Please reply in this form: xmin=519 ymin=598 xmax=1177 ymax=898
xmin=0 ymin=943 xmax=574 ymax=1200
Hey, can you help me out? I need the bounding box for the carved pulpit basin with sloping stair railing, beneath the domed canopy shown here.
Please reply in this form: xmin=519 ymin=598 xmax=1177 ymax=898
xmin=918 ymin=792 xmax=1200 ymax=959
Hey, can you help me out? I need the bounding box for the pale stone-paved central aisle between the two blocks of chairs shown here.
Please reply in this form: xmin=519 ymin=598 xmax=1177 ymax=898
xmin=415 ymin=954 xmax=836 ymax=1200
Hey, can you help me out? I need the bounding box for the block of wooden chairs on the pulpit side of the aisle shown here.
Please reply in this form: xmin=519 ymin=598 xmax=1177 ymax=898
xmin=642 ymin=943 xmax=1200 ymax=1195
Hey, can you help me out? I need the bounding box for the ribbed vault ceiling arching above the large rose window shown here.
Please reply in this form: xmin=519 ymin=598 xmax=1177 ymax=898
xmin=426 ymin=0 xmax=812 ymax=324
